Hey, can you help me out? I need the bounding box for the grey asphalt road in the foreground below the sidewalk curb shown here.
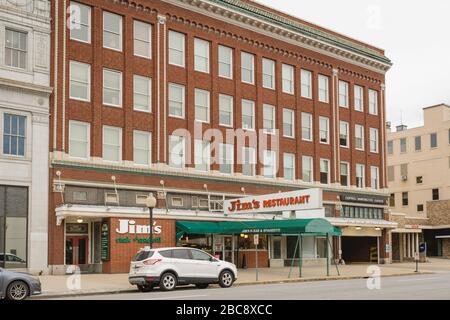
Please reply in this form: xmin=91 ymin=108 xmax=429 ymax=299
xmin=51 ymin=273 xmax=450 ymax=300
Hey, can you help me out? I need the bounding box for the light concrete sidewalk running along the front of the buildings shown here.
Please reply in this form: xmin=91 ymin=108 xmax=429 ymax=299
xmin=34 ymin=259 xmax=450 ymax=299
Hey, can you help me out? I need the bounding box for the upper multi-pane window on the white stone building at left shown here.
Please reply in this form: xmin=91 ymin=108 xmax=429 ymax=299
xmin=5 ymin=29 xmax=27 ymax=69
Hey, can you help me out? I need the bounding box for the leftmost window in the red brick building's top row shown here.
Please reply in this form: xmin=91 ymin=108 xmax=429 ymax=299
xmin=70 ymin=1 xmax=91 ymax=43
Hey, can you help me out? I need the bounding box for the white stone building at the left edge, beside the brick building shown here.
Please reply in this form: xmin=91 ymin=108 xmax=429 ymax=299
xmin=0 ymin=0 xmax=51 ymax=273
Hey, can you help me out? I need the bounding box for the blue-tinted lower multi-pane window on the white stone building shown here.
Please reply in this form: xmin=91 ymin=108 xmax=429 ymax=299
xmin=3 ymin=113 xmax=27 ymax=156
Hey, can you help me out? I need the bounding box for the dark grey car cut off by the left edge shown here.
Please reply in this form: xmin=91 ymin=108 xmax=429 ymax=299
xmin=0 ymin=268 xmax=41 ymax=300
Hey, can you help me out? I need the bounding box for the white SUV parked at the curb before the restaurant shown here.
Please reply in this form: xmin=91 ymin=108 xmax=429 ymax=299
xmin=128 ymin=248 xmax=237 ymax=292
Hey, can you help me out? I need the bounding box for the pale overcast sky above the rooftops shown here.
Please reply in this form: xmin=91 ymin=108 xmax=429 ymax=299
xmin=258 ymin=0 xmax=450 ymax=127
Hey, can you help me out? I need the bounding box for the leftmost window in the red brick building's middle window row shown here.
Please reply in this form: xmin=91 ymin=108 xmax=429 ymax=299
xmin=69 ymin=61 xmax=91 ymax=101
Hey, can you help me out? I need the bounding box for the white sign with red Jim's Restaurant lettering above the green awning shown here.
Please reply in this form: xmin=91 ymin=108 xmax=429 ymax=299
xmin=224 ymin=188 xmax=322 ymax=214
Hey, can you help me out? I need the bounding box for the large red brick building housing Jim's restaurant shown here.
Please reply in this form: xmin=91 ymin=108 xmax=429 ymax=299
xmin=49 ymin=0 xmax=396 ymax=272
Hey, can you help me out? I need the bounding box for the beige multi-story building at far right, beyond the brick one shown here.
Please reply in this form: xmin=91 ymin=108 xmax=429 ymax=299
xmin=387 ymin=104 xmax=450 ymax=261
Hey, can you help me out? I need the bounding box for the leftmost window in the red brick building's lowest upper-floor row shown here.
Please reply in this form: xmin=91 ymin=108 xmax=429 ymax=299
xmin=69 ymin=120 xmax=90 ymax=159
